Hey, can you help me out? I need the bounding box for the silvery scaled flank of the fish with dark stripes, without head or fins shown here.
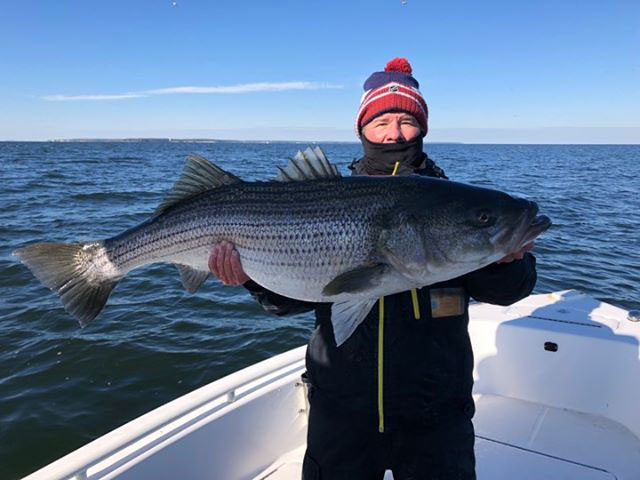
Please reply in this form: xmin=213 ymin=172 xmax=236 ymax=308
xmin=105 ymin=180 xmax=396 ymax=301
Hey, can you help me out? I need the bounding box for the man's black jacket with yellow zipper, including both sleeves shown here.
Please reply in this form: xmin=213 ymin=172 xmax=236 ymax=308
xmin=245 ymin=156 xmax=537 ymax=431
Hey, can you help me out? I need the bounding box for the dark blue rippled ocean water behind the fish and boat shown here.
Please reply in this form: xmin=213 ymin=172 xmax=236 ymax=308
xmin=0 ymin=142 xmax=640 ymax=479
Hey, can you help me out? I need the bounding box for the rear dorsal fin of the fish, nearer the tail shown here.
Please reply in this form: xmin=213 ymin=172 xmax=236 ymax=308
xmin=154 ymin=155 xmax=241 ymax=215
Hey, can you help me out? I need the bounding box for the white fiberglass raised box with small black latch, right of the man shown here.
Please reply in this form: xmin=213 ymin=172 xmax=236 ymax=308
xmin=469 ymin=291 xmax=640 ymax=437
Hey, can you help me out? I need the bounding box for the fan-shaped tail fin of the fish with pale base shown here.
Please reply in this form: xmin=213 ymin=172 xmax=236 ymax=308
xmin=13 ymin=242 xmax=120 ymax=326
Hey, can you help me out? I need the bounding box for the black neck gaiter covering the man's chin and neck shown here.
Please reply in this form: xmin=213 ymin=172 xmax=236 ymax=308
xmin=360 ymin=135 xmax=425 ymax=175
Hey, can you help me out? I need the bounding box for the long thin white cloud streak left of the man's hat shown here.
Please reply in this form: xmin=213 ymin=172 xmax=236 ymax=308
xmin=42 ymin=82 xmax=342 ymax=102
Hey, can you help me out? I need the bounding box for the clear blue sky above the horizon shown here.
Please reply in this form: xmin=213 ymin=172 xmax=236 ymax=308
xmin=0 ymin=0 xmax=640 ymax=143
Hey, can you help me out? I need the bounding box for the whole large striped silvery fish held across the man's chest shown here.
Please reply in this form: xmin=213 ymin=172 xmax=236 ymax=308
xmin=14 ymin=148 xmax=551 ymax=345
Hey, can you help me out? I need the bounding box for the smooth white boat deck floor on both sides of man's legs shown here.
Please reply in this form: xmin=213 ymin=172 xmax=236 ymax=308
xmin=254 ymin=395 xmax=640 ymax=480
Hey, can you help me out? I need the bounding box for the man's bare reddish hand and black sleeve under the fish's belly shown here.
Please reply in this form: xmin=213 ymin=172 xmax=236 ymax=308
xmin=209 ymin=242 xmax=316 ymax=316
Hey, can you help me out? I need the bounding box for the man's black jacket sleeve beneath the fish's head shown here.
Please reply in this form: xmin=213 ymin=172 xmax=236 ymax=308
xmin=464 ymin=245 xmax=538 ymax=305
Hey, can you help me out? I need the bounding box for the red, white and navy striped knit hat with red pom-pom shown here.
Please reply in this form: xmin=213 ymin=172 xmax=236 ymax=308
xmin=356 ymin=58 xmax=429 ymax=136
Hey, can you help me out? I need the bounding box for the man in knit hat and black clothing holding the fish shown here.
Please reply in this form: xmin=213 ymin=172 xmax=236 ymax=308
xmin=209 ymin=59 xmax=536 ymax=480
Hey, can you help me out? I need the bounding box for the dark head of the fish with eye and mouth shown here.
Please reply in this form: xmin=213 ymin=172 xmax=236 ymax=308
xmin=414 ymin=180 xmax=551 ymax=278
